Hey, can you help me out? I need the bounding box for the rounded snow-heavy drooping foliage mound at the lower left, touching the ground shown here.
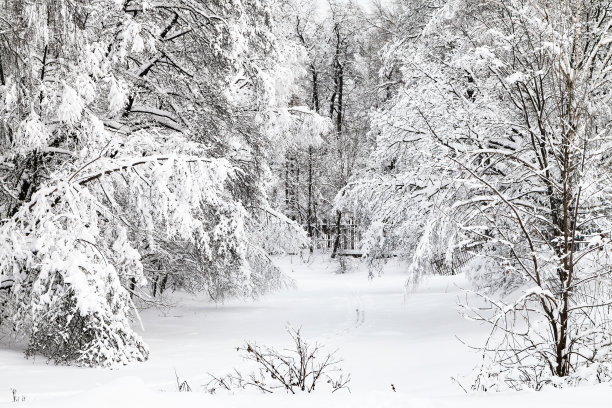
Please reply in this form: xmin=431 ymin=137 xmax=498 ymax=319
xmin=0 ymin=183 xmax=148 ymax=365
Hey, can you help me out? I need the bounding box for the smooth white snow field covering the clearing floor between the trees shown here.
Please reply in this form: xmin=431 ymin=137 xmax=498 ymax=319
xmin=0 ymin=256 xmax=612 ymax=408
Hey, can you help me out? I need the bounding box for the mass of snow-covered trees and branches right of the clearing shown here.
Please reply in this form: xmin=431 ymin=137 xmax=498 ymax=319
xmin=339 ymin=0 xmax=612 ymax=390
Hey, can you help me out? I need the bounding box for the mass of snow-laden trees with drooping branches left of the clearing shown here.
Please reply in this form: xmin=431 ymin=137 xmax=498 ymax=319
xmin=0 ymin=0 xmax=328 ymax=366
